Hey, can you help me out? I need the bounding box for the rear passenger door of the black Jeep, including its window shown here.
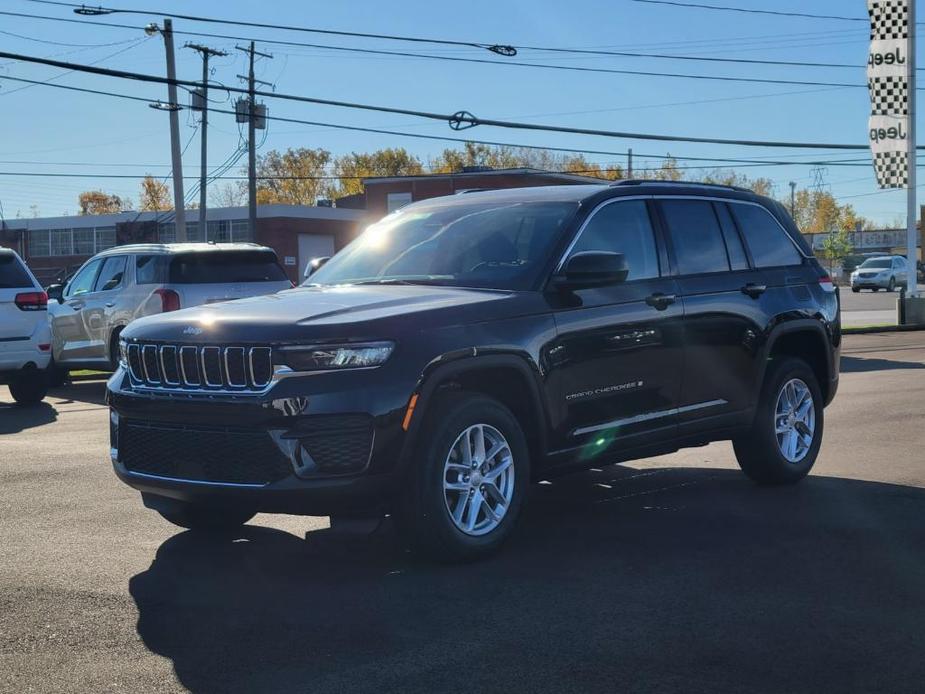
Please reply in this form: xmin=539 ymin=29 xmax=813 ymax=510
xmin=659 ymin=198 xmax=766 ymax=433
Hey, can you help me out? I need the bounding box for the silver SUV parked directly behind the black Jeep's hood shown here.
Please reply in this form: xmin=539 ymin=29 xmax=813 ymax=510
xmin=48 ymin=243 xmax=292 ymax=381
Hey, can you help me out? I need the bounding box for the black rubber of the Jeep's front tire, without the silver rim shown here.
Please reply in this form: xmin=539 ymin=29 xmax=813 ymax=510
xmin=400 ymin=393 xmax=530 ymax=561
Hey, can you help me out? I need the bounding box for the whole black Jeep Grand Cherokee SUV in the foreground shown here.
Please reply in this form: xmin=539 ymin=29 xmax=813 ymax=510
xmin=108 ymin=181 xmax=841 ymax=559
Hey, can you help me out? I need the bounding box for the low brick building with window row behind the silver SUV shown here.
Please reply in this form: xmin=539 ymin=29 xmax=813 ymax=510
xmin=0 ymin=205 xmax=367 ymax=284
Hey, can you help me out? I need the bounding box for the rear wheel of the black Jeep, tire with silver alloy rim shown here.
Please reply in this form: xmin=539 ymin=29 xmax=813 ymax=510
xmin=733 ymin=357 xmax=824 ymax=484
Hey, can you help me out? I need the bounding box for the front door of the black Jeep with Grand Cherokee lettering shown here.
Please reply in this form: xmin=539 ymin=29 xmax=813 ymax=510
xmin=546 ymin=199 xmax=683 ymax=460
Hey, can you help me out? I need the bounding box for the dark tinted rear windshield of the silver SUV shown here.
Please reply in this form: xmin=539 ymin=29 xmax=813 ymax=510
xmin=168 ymin=250 xmax=288 ymax=284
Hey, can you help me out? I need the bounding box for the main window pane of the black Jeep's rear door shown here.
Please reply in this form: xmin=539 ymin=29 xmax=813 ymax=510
xmin=661 ymin=200 xmax=729 ymax=275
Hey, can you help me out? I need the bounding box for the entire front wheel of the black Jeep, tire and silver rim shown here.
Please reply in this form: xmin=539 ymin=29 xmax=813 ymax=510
xmin=395 ymin=393 xmax=530 ymax=562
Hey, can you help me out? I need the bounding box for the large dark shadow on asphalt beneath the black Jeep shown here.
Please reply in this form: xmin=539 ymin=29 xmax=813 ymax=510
xmin=129 ymin=467 xmax=925 ymax=693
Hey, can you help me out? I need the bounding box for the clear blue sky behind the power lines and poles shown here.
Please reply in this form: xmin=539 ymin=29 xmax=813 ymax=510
xmin=0 ymin=0 xmax=905 ymax=224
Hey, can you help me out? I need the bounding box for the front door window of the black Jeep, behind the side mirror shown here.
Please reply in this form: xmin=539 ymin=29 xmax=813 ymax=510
xmin=571 ymin=200 xmax=658 ymax=281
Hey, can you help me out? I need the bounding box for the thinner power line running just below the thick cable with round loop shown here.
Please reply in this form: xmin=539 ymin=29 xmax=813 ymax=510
xmin=0 ymin=75 xmax=888 ymax=166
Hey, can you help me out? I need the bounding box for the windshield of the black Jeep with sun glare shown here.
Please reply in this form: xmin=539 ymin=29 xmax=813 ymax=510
xmin=306 ymin=202 xmax=578 ymax=289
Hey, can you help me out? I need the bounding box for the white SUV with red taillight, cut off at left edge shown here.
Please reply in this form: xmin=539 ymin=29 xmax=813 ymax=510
xmin=0 ymin=248 xmax=51 ymax=405
